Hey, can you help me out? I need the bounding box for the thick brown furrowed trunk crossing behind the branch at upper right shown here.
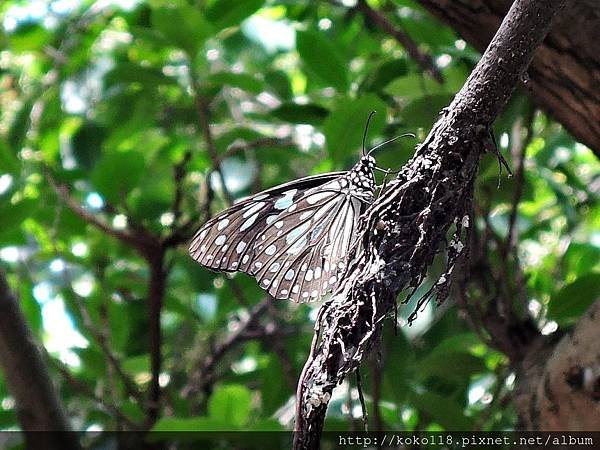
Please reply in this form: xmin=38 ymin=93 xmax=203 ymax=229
xmin=419 ymin=0 xmax=600 ymax=156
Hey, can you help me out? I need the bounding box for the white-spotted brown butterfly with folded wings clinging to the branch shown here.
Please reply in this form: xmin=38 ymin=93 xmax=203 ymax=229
xmin=189 ymin=113 xmax=410 ymax=302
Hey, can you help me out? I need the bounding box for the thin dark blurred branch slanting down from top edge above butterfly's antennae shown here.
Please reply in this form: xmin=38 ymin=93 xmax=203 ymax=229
xmin=355 ymin=0 xmax=444 ymax=84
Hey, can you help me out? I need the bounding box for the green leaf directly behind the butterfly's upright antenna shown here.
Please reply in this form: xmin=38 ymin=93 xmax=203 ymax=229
xmin=323 ymin=94 xmax=386 ymax=161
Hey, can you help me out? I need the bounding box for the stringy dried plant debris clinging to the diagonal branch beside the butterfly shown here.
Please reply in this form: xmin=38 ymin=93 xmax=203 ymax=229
xmin=302 ymin=113 xmax=489 ymax=422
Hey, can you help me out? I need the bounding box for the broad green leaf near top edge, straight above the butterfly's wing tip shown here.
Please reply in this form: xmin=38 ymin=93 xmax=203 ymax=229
xmin=151 ymin=3 xmax=214 ymax=57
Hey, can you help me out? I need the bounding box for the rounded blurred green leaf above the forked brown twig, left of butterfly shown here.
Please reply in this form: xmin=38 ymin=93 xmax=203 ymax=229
xmin=92 ymin=150 xmax=144 ymax=204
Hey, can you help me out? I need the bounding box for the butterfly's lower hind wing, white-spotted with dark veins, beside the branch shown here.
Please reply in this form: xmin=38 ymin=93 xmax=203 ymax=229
xmin=250 ymin=180 xmax=365 ymax=301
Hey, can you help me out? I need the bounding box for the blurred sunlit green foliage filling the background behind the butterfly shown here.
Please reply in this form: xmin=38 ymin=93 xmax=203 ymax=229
xmin=0 ymin=0 xmax=600 ymax=440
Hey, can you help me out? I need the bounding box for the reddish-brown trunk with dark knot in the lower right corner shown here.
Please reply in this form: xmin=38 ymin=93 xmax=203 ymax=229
xmin=515 ymin=300 xmax=600 ymax=431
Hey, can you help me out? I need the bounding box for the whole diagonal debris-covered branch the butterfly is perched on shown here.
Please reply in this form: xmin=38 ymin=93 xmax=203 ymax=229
xmin=294 ymin=0 xmax=564 ymax=449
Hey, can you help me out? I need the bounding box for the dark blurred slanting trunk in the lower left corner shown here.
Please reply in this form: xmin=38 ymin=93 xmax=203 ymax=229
xmin=0 ymin=271 xmax=80 ymax=450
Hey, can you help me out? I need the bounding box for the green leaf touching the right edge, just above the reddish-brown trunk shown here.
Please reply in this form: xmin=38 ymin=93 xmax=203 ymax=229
xmin=548 ymin=273 xmax=600 ymax=325
